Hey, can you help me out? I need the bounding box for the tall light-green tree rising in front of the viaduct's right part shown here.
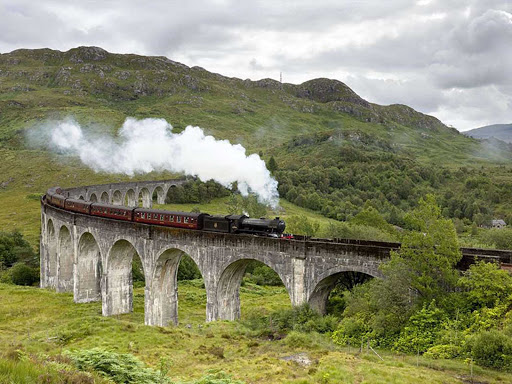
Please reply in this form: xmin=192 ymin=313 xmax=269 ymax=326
xmin=337 ymin=196 xmax=461 ymax=350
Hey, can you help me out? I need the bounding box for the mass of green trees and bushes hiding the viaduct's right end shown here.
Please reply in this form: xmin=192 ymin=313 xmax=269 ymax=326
xmin=333 ymin=196 xmax=512 ymax=370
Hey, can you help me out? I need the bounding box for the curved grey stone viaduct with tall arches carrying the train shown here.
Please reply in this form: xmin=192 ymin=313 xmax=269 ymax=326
xmin=41 ymin=180 xmax=512 ymax=326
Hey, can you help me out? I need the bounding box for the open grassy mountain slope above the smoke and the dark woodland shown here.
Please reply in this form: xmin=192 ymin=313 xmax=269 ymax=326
xmin=0 ymin=47 xmax=496 ymax=162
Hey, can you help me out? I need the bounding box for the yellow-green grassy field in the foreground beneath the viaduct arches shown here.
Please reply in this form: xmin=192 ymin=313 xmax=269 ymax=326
xmin=0 ymin=281 xmax=512 ymax=384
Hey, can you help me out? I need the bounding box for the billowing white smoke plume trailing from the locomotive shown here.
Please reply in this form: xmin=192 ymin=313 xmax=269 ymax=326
xmin=51 ymin=118 xmax=279 ymax=208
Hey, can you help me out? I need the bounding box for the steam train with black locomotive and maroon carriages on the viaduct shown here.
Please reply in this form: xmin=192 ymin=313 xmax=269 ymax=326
xmin=43 ymin=187 xmax=286 ymax=237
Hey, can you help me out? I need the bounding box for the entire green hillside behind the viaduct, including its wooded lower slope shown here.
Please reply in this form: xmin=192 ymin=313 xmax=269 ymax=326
xmin=0 ymin=47 xmax=512 ymax=242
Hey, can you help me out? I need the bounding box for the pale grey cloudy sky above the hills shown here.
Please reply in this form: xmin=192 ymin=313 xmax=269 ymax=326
xmin=0 ymin=0 xmax=512 ymax=130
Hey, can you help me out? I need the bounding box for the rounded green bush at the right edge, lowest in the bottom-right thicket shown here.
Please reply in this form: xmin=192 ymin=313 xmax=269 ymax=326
xmin=469 ymin=330 xmax=512 ymax=370
